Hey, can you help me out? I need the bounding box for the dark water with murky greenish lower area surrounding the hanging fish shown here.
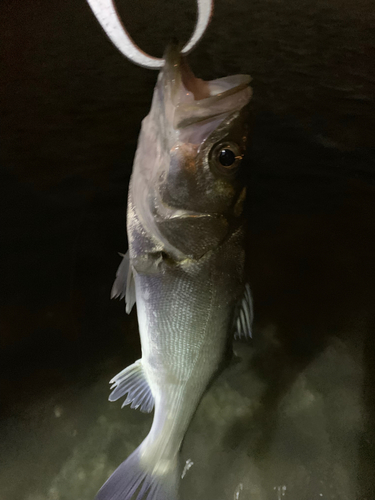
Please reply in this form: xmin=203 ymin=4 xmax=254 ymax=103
xmin=0 ymin=0 xmax=375 ymax=500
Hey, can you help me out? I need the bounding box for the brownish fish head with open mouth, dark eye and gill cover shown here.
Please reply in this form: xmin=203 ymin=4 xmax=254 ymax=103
xmin=134 ymin=44 xmax=252 ymax=259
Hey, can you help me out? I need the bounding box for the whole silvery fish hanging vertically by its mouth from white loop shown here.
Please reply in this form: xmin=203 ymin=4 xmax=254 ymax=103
xmin=96 ymin=43 xmax=253 ymax=500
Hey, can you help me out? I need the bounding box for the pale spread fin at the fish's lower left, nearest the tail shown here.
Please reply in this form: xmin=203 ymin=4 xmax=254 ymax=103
xmin=108 ymin=359 xmax=154 ymax=413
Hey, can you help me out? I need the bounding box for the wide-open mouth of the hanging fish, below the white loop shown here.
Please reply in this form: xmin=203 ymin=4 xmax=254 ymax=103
xmin=160 ymin=41 xmax=252 ymax=129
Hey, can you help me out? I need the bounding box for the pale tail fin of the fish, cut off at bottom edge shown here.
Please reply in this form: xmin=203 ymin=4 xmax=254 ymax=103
xmin=95 ymin=447 xmax=178 ymax=500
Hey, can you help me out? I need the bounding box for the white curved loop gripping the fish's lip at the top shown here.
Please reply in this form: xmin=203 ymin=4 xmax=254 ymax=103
xmin=87 ymin=0 xmax=214 ymax=69
